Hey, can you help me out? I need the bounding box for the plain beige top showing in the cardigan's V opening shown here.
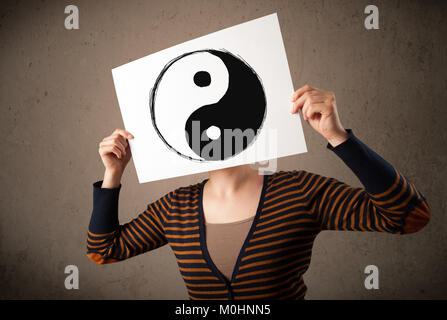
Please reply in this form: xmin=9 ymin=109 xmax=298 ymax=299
xmin=205 ymin=216 xmax=255 ymax=280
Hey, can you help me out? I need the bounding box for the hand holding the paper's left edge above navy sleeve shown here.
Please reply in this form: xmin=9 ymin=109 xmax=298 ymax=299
xmin=98 ymin=129 xmax=134 ymax=188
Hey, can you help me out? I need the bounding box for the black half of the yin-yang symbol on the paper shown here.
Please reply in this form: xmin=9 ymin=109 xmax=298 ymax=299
xmin=185 ymin=50 xmax=266 ymax=161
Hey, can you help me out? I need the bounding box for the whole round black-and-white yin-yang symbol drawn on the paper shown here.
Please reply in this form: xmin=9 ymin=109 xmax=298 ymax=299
xmin=149 ymin=49 xmax=266 ymax=161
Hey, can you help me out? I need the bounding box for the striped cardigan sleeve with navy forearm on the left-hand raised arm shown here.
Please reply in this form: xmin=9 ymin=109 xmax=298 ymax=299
xmin=87 ymin=181 xmax=169 ymax=264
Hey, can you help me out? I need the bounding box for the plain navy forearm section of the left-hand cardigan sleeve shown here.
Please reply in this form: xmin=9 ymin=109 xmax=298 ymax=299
xmin=89 ymin=180 xmax=121 ymax=234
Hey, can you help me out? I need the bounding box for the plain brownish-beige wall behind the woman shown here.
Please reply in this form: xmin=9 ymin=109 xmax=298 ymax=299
xmin=0 ymin=0 xmax=447 ymax=299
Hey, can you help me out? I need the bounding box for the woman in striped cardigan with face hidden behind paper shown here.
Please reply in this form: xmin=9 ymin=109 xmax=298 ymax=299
xmin=87 ymin=85 xmax=430 ymax=300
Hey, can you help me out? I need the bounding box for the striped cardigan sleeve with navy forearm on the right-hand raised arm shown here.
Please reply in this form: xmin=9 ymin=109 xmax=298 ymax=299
xmin=315 ymin=130 xmax=430 ymax=234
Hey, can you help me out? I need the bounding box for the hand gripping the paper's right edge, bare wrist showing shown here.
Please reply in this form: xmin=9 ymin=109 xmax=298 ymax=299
xmin=291 ymin=84 xmax=349 ymax=147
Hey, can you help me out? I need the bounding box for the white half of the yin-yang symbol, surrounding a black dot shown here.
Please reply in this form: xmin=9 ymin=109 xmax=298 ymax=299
xmin=153 ymin=52 xmax=229 ymax=160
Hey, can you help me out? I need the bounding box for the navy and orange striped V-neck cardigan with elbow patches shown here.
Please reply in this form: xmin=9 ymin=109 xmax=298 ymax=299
xmin=87 ymin=130 xmax=430 ymax=300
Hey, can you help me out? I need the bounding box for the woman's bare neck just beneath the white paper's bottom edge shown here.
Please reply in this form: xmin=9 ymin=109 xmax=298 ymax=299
xmin=206 ymin=164 xmax=263 ymax=198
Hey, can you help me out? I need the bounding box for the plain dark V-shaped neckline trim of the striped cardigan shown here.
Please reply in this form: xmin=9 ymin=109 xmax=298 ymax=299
xmin=198 ymin=175 xmax=268 ymax=294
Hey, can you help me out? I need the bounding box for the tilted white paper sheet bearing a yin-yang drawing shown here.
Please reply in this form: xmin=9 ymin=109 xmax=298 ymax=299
xmin=112 ymin=13 xmax=307 ymax=183
